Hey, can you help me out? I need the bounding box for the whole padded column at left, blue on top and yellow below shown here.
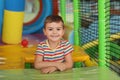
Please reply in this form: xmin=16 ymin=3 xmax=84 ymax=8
xmin=2 ymin=0 xmax=25 ymax=44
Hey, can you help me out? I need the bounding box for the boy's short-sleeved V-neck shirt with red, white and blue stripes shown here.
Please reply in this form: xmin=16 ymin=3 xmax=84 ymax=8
xmin=36 ymin=40 xmax=73 ymax=62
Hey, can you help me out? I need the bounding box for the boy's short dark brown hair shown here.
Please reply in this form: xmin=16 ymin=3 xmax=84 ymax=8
xmin=44 ymin=15 xmax=64 ymax=28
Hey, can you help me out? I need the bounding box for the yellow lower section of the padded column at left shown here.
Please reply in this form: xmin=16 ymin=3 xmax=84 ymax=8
xmin=2 ymin=10 xmax=24 ymax=44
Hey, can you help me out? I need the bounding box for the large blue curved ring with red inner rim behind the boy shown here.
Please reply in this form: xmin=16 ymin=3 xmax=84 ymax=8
xmin=23 ymin=0 xmax=52 ymax=34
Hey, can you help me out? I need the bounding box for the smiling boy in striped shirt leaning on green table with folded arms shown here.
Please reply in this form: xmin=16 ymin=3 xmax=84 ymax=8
xmin=34 ymin=15 xmax=73 ymax=73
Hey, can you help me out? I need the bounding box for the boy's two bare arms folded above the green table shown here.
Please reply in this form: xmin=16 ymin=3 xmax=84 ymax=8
xmin=34 ymin=54 xmax=73 ymax=71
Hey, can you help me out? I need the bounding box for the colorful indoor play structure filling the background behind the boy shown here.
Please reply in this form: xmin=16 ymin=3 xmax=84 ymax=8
xmin=0 ymin=0 xmax=120 ymax=79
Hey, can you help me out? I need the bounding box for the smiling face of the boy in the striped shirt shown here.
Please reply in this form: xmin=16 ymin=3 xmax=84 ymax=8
xmin=43 ymin=22 xmax=64 ymax=42
